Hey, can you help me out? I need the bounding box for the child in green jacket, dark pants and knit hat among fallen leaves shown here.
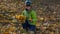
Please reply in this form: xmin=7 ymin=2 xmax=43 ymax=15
xmin=22 ymin=1 xmax=37 ymax=32
